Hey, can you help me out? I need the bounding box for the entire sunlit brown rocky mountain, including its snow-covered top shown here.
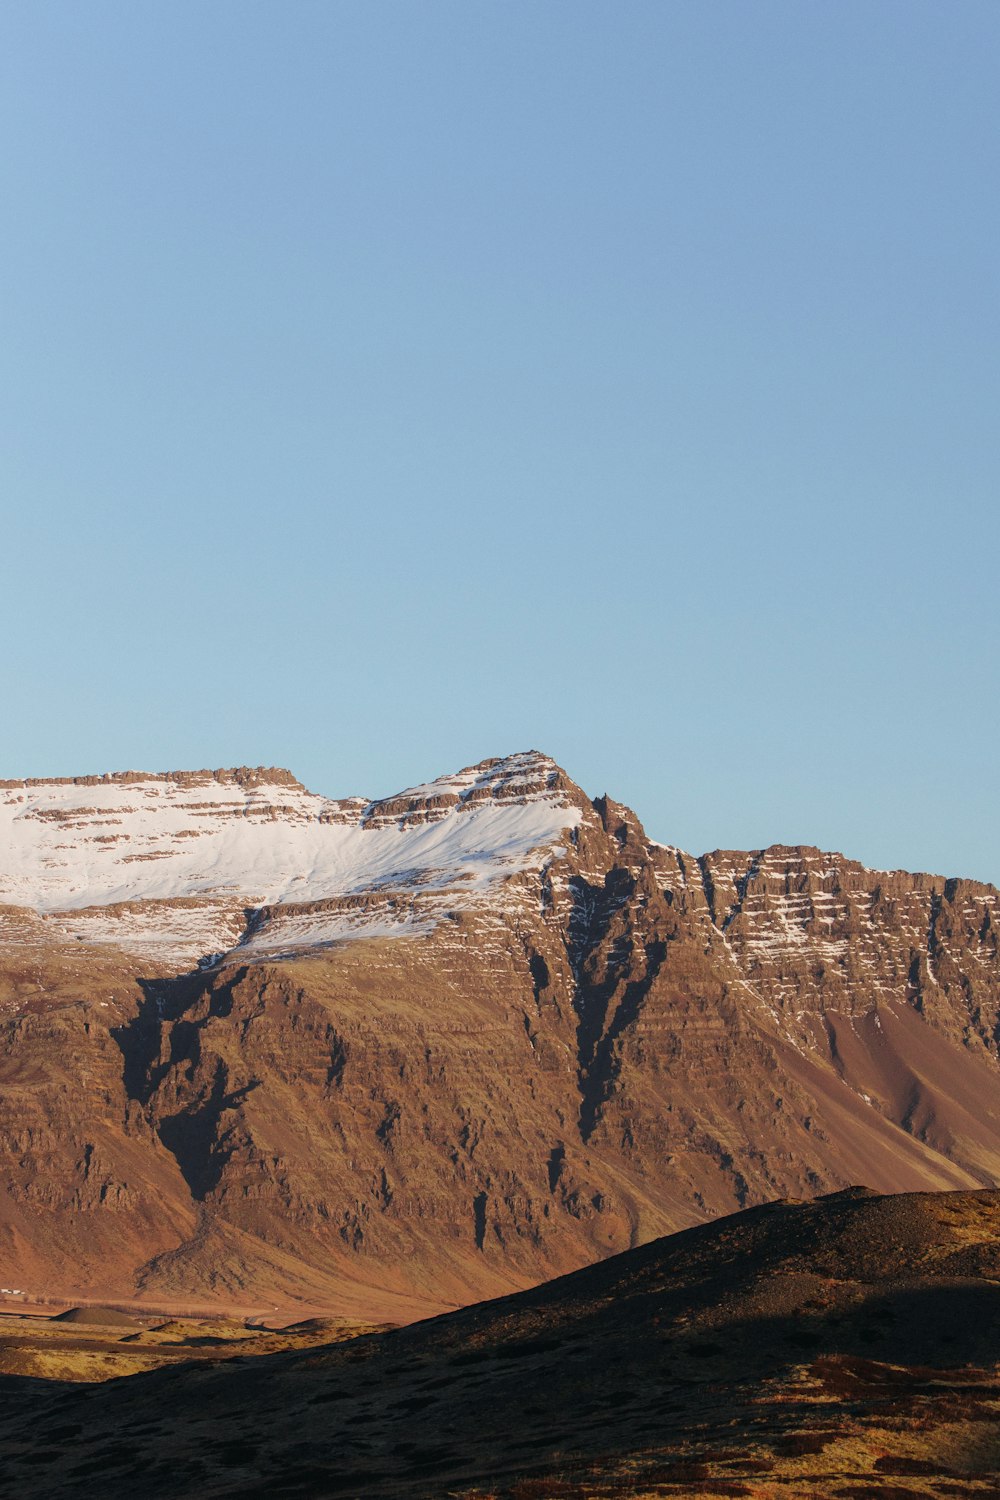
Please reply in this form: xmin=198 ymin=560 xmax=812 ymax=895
xmin=0 ymin=753 xmax=1000 ymax=1320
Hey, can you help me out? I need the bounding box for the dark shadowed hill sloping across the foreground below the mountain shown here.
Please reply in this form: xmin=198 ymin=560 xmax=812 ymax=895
xmin=0 ymin=1188 xmax=1000 ymax=1500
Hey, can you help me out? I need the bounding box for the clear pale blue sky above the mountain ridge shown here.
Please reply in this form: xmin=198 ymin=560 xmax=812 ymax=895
xmin=0 ymin=0 xmax=1000 ymax=881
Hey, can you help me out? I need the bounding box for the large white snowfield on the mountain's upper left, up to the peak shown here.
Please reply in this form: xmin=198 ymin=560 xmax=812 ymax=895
xmin=0 ymin=752 xmax=582 ymax=959
